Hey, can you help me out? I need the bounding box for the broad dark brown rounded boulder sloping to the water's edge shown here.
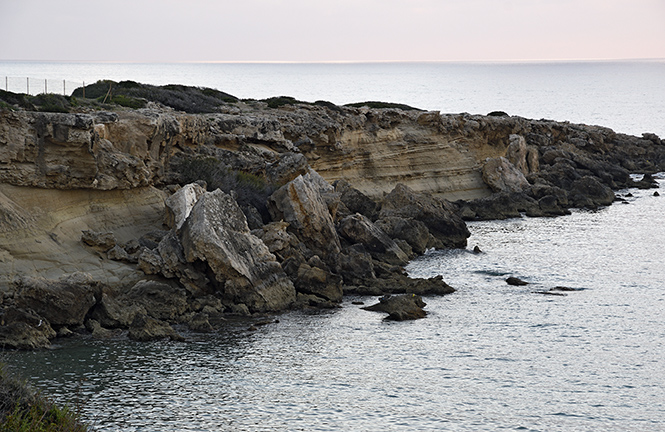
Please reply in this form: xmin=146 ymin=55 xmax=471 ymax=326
xmin=379 ymin=184 xmax=471 ymax=247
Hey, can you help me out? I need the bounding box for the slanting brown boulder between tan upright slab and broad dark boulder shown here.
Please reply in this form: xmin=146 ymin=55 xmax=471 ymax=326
xmin=338 ymin=213 xmax=409 ymax=265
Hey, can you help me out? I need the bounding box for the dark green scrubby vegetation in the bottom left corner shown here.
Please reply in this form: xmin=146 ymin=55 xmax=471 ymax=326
xmin=0 ymin=364 xmax=90 ymax=432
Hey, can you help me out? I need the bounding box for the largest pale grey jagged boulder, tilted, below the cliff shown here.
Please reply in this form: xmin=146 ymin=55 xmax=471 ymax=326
xmin=180 ymin=189 xmax=295 ymax=312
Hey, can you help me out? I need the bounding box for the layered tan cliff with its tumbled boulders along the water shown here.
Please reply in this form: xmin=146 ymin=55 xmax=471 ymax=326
xmin=0 ymin=85 xmax=665 ymax=349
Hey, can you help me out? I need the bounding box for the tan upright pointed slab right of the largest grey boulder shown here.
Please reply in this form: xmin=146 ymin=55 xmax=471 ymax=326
xmin=268 ymin=173 xmax=341 ymax=267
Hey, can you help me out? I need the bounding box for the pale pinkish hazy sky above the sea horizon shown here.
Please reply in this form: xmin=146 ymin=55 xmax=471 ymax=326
xmin=0 ymin=0 xmax=665 ymax=62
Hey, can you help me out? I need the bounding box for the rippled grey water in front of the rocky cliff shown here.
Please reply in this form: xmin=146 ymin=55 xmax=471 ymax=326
xmin=5 ymin=180 xmax=665 ymax=431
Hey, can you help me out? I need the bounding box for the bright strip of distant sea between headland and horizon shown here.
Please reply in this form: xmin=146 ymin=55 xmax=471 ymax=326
xmin=0 ymin=60 xmax=665 ymax=137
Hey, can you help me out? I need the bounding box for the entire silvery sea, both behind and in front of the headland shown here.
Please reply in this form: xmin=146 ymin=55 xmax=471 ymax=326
xmin=0 ymin=60 xmax=665 ymax=432
